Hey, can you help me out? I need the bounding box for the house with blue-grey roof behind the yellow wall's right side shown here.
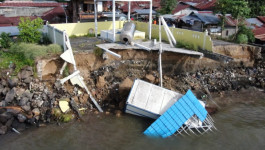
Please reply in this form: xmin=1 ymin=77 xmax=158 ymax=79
xmin=181 ymin=12 xmax=220 ymax=32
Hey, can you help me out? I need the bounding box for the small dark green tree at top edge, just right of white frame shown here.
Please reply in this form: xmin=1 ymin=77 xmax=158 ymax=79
xmin=160 ymin=0 xmax=177 ymax=14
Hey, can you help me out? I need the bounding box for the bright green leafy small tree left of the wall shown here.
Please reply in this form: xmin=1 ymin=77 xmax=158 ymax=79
xmin=18 ymin=17 xmax=43 ymax=43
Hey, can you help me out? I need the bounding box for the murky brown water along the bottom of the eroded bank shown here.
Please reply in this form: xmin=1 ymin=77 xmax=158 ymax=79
xmin=0 ymin=89 xmax=265 ymax=150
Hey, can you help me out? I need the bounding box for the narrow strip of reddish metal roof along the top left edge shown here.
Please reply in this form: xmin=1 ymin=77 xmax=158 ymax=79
xmin=0 ymin=1 xmax=61 ymax=7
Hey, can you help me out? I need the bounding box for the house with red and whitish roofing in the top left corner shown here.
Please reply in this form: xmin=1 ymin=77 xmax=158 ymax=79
xmin=0 ymin=1 xmax=67 ymax=26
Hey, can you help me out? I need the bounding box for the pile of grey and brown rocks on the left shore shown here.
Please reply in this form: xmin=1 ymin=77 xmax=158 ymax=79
xmin=0 ymin=67 xmax=91 ymax=135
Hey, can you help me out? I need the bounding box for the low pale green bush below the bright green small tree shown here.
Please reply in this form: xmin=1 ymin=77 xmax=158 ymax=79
xmin=10 ymin=43 xmax=62 ymax=59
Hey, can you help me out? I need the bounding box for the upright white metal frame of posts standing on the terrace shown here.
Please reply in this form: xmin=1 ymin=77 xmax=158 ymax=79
xmin=94 ymin=0 xmax=153 ymax=42
